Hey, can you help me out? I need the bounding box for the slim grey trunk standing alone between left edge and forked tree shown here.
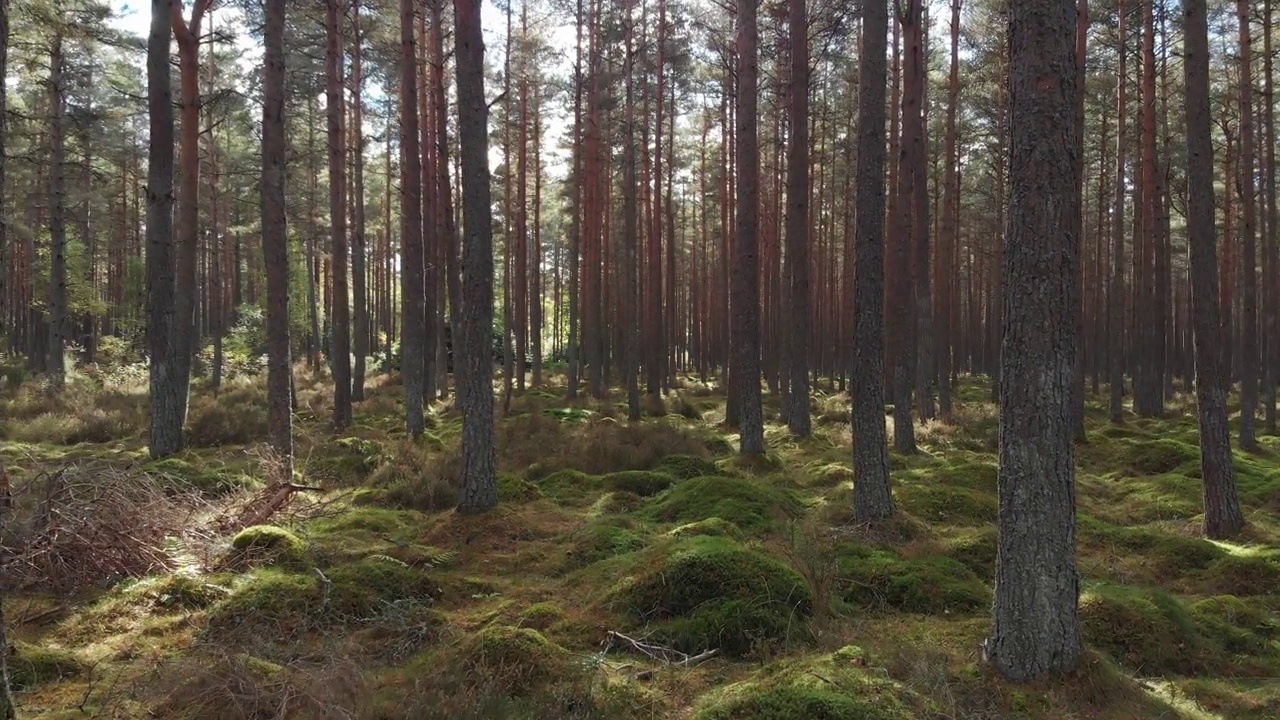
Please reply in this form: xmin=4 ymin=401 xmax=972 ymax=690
xmin=47 ymin=29 xmax=67 ymax=388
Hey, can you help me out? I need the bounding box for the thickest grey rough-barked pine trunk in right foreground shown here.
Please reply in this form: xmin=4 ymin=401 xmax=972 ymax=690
xmin=986 ymin=0 xmax=1082 ymax=682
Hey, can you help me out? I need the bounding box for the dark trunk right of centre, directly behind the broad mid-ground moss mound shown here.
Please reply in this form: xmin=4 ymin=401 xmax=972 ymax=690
xmin=732 ymin=0 xmax=764 ymax=455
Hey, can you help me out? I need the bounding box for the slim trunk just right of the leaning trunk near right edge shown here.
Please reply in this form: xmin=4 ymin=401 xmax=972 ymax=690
xmin=1236 ymin=0 xmax=1258 ymax=450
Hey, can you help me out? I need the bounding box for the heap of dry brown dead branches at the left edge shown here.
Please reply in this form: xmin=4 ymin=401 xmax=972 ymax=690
xmin=0 ymin=460 xmax=205 ymax=593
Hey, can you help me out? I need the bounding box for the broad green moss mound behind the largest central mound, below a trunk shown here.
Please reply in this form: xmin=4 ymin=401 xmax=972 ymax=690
xmin=650 ymin=477 xmax=801 ymax=533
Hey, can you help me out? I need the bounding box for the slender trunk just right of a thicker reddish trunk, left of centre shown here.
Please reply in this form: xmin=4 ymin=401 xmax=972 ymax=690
xmin=351 ymin=0 xmax=369 ymax=400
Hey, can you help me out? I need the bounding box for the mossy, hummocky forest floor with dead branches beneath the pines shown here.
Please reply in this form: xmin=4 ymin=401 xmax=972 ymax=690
xmin=0 ymin=373 xmax=1280 ymax=720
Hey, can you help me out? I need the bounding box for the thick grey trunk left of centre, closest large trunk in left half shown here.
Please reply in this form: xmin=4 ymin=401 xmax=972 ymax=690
xmin=455 ymin=0 xmax=498 ymax=512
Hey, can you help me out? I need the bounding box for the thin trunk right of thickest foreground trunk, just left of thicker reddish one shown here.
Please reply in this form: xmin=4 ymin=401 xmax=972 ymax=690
xmin=1107 ymin=0 xmax=1129 ymax=424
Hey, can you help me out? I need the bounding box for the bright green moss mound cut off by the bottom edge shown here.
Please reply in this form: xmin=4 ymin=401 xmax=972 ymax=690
xmin=694 ymin=648 xmax=933 ymax=720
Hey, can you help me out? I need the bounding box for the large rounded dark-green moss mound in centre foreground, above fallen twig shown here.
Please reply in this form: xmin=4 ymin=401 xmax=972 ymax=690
xmin=617 ymin=536 xmax=813 ymax=656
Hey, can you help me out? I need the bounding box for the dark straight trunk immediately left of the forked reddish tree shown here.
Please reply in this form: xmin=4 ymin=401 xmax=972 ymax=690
xmin=146 ymin=0 xmax=186 ymax=457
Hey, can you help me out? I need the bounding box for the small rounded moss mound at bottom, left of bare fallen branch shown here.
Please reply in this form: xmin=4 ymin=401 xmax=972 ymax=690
xmin=461 ymin=625 xmax=570 ymax=694
